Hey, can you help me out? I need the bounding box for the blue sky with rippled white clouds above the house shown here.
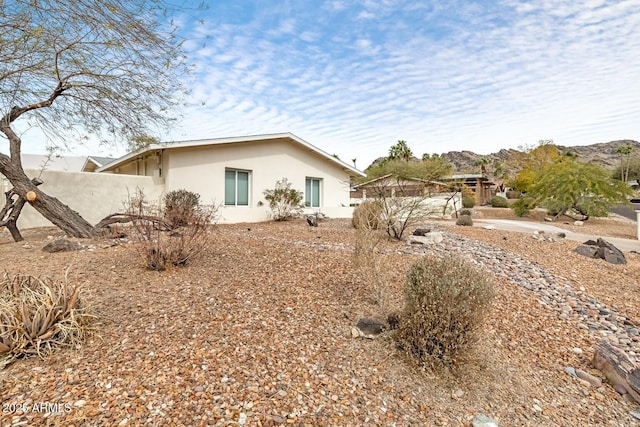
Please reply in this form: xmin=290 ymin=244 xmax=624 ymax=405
xmin=26 ymin=0 xmax=640 ymax=169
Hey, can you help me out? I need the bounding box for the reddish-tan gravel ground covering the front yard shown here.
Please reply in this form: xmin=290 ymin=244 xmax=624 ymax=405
xmin=0 ymin=214 xmax=640 ymax=426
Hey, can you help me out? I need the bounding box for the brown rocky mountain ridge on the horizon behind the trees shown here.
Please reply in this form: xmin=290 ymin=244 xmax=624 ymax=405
xmin=441 ymin=139 xmax=640 ymax=172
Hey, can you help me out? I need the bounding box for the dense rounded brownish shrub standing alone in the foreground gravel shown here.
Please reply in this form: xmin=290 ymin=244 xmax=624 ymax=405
xmin=395 ymin=255 xmax=494 ymax=372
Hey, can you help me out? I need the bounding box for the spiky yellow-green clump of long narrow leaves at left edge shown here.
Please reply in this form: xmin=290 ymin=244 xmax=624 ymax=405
xmin=0 ymin=272 xmax=94 ymax=368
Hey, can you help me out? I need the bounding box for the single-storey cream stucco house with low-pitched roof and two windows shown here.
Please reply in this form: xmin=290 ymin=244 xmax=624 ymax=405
xmin=95 ymin=133 xmax=365 ymax=222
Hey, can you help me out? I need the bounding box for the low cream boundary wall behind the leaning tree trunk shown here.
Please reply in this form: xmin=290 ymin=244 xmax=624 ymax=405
xmin=0 ymin=170 xmax=164 ymax=228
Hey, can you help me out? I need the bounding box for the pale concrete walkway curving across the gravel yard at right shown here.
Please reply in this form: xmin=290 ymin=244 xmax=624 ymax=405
xmin=473 ymin=218 xmax=640 ymax=252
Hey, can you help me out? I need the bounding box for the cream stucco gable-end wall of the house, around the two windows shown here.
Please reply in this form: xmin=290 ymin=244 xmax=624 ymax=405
xmin=163 ymin=140 xmax=353 ymax=223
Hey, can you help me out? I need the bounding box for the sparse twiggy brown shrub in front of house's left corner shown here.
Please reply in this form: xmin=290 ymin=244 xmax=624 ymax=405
xmin=127 ymin=190 xmax=218 ymax=271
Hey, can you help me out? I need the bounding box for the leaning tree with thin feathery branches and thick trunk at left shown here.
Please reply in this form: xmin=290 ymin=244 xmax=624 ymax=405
xmin=0 ymin=0 xmax=192 ymax=241
